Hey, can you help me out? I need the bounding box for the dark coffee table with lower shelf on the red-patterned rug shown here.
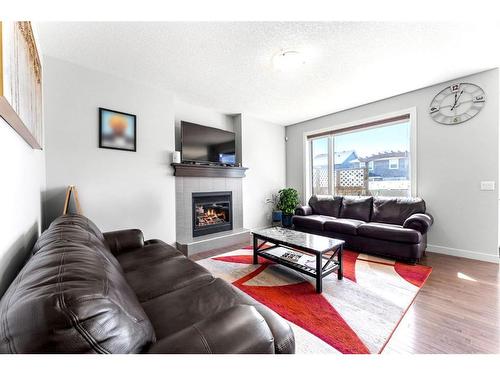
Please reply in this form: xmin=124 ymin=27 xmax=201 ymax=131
xmin=252 ymin=227 xmax=345 ymax=293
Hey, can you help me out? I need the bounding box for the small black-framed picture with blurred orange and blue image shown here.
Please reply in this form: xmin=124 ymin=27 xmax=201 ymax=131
xmin=99 ymin=108 xmax=137 ymax=152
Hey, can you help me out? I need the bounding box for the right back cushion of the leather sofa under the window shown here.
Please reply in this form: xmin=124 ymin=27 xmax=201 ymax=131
xmin=371 ymin=197 xmax=425 ymax=225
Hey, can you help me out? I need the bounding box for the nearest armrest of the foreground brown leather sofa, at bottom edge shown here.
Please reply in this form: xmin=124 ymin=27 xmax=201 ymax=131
xmin=148 ymin=305 xmax=274 ymax=354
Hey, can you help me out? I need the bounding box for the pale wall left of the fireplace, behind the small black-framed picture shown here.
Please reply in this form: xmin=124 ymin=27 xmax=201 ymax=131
xmin=44 ymin=57 xmax=175 ymax=243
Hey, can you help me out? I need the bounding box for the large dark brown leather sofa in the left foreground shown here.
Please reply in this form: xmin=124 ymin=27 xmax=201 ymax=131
xmin=0 ymin=215 xmax=295 ymax=353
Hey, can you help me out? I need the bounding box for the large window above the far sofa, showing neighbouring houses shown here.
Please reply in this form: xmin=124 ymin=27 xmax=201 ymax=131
xmin=308 ymin=114 xmax=415 ymax=197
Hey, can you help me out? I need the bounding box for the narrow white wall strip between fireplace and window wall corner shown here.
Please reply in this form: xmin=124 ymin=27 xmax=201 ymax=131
xmin=241 ymin=114 xmax=286 ymax=229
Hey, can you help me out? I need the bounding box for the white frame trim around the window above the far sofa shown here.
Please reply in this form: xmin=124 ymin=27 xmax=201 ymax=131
xmin=302 ymin=107 xmax=418 ymax=202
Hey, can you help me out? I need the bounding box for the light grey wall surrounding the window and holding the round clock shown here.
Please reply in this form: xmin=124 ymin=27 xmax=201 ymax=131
xmin=286 ymin=69 xmax=499 ymax=261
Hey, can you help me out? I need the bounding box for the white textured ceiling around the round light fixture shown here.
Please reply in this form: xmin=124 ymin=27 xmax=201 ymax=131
xmin=37 ymin=22 xmax=500 ymax=125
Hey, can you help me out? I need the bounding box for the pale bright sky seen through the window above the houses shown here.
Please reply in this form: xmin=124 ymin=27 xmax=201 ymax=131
xmin=313 ymin=122 xmax=410 ymax=157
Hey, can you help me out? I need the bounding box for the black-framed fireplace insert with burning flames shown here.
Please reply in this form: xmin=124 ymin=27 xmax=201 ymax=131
xmin=192 ymin=191 xmax=233 ymax=237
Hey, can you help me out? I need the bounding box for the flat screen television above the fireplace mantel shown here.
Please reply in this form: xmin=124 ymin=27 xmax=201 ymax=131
xmin=181 ymin=121 xmax=236 ymax=165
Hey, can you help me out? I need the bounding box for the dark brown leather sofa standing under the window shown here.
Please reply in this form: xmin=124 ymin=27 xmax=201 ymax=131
xmin=292 ymin=195 xmax=433 ymax=263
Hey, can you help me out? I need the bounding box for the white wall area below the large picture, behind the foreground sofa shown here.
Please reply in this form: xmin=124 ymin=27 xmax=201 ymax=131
xmin=0 ymin=118 xmax=45 ymax=298
